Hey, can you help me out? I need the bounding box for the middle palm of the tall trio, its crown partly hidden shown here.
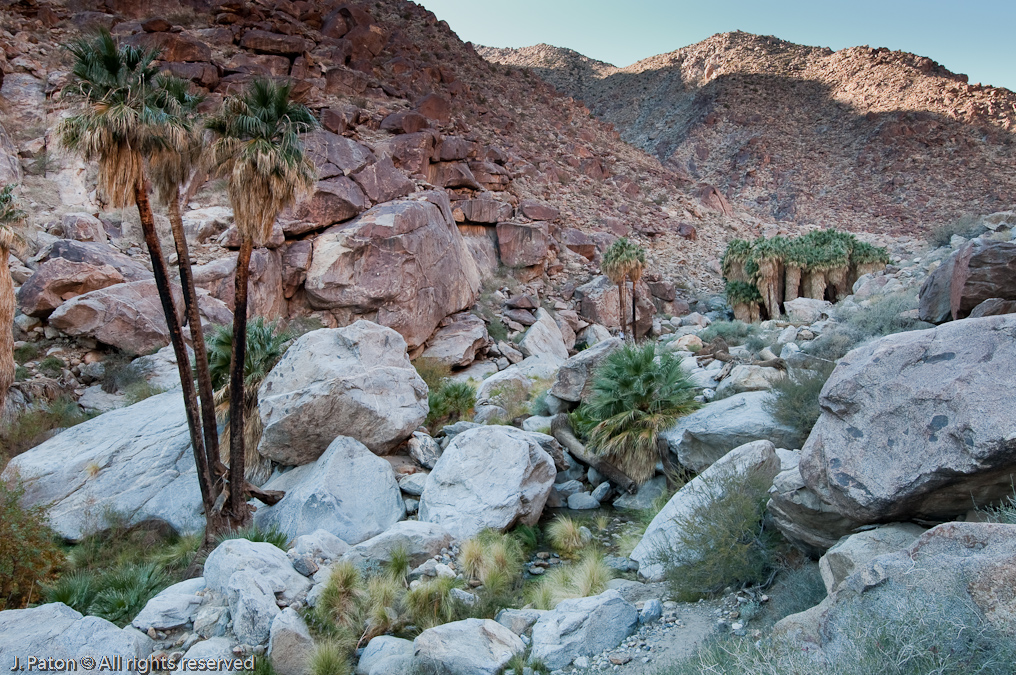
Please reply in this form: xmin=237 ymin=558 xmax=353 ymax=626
xmin=148 ymin=75 xmax=223 ymax=494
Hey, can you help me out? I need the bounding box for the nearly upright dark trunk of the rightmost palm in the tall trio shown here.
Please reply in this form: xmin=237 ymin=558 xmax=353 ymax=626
xmin=229 ymin=235 xmax=253 ymax=527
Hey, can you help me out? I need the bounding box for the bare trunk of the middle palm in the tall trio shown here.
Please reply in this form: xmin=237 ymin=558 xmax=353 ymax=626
xmin=169 ymin=189 xmax=220 ymax=495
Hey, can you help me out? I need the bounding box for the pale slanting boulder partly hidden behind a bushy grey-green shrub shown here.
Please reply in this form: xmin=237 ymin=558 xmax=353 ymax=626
xmin=629 ymin=440 xmax=780 ymax=581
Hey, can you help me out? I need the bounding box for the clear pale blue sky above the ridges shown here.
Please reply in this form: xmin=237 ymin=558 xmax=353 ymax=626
xmin=419 ymin=0 xmax=1016 ymax=90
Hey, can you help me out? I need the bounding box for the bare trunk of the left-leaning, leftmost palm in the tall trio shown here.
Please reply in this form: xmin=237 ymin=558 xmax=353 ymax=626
xmin=134 ymin=178 xmax=217 ymax=537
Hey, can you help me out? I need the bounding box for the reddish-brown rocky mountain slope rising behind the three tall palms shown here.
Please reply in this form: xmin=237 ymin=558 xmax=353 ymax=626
xmin=0 ymin=0 xmax=761 ymax=288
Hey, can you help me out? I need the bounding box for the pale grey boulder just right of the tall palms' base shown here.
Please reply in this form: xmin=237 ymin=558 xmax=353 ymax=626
xmin=254 ymin=436 xmax=405 ymax=544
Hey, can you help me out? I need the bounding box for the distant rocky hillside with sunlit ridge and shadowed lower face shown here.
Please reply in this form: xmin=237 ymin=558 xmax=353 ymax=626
xmin=480 ymin=32 xmax=1016 ymax=234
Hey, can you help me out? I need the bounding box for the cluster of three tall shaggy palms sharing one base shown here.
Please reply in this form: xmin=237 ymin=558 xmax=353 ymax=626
xmin=48 ymin=32 xmax=316 ymax=543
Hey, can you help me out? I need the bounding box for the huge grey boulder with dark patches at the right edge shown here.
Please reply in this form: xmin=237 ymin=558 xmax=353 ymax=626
xmin=801 ymin=314 xmax=1016 ymax=523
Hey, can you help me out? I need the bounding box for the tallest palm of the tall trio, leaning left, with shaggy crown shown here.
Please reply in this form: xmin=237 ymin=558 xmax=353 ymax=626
xmin=57 ymin=29 xmax=224 ymax=541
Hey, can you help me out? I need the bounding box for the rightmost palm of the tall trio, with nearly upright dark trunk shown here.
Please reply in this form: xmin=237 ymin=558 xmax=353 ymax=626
xmin=206 ymin=78 xmax=317 ymax=523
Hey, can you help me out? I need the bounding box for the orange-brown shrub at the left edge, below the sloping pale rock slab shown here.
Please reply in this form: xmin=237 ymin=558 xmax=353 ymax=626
xmin=0 ymin=480 xmax=63 ymax=610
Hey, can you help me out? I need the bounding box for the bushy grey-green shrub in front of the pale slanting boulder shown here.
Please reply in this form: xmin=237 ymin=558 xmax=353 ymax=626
xmin=653 ymin=472 xmax=783 ymax=601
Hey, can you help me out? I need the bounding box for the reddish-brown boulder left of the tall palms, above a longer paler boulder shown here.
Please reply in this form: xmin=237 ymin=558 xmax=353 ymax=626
xmin=17 ymin=258 xmax=126 ymax=318
